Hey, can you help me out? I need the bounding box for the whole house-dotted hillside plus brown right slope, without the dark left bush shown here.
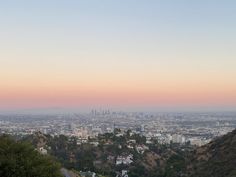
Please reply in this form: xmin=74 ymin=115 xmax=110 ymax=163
xmin=6 ymin=130 xmax=236 ymax=177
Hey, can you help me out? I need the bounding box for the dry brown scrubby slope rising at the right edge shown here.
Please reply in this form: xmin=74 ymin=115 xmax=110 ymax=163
xmin=187 ymin=130 xmax=236 ymax=177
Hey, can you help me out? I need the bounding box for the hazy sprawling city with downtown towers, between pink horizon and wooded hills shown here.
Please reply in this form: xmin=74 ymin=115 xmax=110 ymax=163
xmin=0 ymin=109 xmax=236 ymax=146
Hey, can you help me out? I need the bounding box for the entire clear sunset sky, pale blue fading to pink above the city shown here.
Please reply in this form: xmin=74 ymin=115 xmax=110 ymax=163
xmin=0 ymin=0 xmax=236 ymax=110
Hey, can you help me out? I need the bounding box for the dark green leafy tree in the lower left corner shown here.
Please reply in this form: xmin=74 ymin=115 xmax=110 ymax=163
xmin=0 ymin=136 xmax=62 ymax=177
